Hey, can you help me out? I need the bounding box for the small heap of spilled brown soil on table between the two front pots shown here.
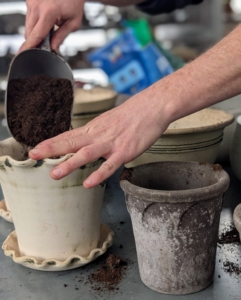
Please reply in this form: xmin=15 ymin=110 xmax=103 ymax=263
xmin=88 ymin=254 xmax=127 ymax=291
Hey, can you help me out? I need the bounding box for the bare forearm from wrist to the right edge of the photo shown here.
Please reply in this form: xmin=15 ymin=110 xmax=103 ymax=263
xmin=149 ymin=26 xmax=241 ymax=122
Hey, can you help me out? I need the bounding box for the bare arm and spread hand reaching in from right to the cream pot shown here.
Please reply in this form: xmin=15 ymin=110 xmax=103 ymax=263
xmin=30 ymin=26 xmax=241 ymax=188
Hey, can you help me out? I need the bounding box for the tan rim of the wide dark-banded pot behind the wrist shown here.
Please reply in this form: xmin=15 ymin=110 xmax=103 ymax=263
xmin=163 ymin=108 xmax=234 ymax=136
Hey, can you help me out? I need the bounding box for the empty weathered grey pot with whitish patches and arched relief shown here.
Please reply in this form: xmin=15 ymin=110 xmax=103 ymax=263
xmin=120 ymin=162 xmax=229 ymax=294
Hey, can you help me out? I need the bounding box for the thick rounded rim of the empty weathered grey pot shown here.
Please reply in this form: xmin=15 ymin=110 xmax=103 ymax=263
xmin=120 ymin=161 xmax=230 ymax=203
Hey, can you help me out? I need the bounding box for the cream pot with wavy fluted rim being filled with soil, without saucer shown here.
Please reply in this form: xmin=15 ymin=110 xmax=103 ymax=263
xmin=0 ymin=138 xmax=104 ymax=261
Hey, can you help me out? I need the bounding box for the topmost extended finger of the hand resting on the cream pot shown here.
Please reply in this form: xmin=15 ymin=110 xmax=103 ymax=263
xmin=29 ymin=133 xmax=91 ymax=160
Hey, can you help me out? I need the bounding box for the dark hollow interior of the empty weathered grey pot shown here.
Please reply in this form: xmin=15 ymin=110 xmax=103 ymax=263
xmin=129 ymin=162 xmax=222 ymax=191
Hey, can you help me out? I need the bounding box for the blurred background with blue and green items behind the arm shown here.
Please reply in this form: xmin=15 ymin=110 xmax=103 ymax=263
xmin=0 ymin=0 xmax=241 ymax=103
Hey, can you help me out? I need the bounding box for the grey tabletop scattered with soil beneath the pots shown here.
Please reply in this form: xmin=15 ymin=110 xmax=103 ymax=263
xmin=0 ymin=126 xmax=241 ymax=300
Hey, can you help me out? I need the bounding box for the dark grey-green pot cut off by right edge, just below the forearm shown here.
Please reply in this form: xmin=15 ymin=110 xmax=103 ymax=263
xmin=230 ymin=115 xmax=241 ymax=180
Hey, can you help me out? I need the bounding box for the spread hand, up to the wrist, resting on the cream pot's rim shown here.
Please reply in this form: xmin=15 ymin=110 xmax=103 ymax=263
xmin=29 ymin=90 xmax=169 ymax=188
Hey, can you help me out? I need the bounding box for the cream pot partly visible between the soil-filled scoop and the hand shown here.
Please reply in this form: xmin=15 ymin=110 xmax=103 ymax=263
xmin=72 ymin=87 xmax=117 ymax=128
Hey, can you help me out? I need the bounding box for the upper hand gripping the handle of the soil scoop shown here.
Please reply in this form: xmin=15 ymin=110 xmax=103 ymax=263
xmin=19 ymin=0 xmax=85 ymax=51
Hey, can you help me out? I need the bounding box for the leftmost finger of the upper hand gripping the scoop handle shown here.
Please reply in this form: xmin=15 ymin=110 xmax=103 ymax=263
xmin=19 ymin=17 xmax=55 ymax=51
